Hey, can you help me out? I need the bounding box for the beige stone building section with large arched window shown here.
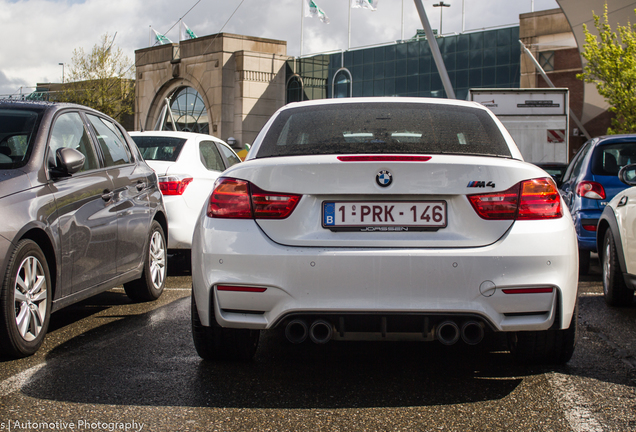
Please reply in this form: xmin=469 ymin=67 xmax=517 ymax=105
xmin=134 ymin=33 xmax=288 ymax=148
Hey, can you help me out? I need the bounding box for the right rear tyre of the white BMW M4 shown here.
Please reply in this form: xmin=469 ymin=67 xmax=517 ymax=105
xmin=508 ymin=305 xmax=578 ymax=365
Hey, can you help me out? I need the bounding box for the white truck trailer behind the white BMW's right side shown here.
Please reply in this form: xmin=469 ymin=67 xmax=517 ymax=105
xmin=469 ymin=88 xmax=570 ymax=163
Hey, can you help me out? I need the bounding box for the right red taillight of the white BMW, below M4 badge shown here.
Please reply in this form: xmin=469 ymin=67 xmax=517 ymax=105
xmin=468 ymin=178 xmax=563 ymax=220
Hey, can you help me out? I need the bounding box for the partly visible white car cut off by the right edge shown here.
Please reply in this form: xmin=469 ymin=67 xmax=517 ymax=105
xmin=596 ymin=164 xmax=636 ymax=306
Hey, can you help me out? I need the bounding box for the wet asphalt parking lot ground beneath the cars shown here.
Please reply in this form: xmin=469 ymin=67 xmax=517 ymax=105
xmin=0 ymin=258 xmax=636 ymax=431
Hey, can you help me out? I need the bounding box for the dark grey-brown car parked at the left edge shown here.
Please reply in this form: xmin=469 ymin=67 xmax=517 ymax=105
xmin=0 ymin=100 xmax=168 ymax=357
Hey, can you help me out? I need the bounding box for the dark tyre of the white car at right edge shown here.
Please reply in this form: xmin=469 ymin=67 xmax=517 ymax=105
xmin=602 ymin=229 xmax=634 ymax=306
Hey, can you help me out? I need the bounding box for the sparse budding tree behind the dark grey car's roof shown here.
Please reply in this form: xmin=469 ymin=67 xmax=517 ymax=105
xmin=59 ymin=33 xmax=135 ymax=124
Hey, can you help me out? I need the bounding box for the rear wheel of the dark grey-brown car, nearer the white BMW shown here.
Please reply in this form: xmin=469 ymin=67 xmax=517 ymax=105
xmin=124 ymin=221 xmax=168 ymax=301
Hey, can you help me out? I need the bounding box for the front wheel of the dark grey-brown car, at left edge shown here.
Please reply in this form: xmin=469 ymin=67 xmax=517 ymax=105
xmin=0 ymin=239 xmax=53 ymax=358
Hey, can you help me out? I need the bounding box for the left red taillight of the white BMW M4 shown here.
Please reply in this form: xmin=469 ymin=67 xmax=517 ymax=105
xmin=207 ymin=177 xmax=301 ymax=219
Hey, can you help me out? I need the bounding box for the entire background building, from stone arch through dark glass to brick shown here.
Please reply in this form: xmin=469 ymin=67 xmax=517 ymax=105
xmin=134 ymin=0 xmax=636 ymax=157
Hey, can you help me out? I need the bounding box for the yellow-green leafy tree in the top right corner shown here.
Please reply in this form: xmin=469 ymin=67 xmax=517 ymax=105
xmin=577 ymin=3 xmax=636 ymax=134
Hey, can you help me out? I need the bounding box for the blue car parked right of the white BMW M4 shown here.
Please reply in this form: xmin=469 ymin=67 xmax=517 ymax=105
xmin=560 ymin=134 xmax=636 ymax=274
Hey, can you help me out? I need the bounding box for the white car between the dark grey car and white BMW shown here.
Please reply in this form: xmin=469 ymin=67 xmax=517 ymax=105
xmin=130 ymin=131 xmax=241 ymax=253
